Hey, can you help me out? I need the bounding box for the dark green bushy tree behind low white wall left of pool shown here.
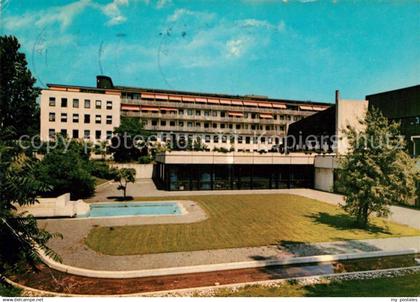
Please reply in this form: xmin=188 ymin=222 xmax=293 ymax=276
xmin=36 ymin=136 xmax=95 ymax=199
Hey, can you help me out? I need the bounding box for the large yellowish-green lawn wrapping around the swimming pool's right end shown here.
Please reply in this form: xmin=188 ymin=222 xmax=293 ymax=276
xmin=86 ymin=194 xmax=420 ymax=255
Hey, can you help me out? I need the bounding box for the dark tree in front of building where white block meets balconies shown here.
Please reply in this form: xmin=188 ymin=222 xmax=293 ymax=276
xmin=109 ymin=117 xmax=151 ymax=162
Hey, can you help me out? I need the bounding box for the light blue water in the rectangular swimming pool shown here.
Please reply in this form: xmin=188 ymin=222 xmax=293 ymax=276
xmin=88 ymin=202 xmax=181 ymax=217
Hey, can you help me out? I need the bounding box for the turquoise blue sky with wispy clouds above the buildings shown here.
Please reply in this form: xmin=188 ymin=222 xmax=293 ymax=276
xmin=0 ymin=0 xmax=420 ymax=102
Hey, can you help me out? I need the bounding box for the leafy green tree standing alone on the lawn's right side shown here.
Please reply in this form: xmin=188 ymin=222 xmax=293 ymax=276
xmin=337 ymin=108 xmax=418 ymax=227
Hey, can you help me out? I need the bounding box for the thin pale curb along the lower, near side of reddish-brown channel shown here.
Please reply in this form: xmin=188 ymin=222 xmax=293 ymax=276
xmin=4 ymin=266 xmax=420 ymax=297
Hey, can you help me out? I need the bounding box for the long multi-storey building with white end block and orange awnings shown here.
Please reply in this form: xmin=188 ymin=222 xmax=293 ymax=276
xmin=41 ymin=76 xmax=330 ymax=151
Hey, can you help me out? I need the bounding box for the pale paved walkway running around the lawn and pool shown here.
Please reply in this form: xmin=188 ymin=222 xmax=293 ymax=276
xmin=40 ymin=179 xmax=420 ymax=271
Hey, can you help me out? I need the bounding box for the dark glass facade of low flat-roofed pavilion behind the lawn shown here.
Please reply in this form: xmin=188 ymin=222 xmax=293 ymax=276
xmin=154 ymin=163 xmax=314 ymax=191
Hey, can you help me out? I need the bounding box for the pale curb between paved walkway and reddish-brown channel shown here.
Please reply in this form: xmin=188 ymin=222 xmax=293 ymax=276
xmin=38 ymin=249 xmax=417 ymax=279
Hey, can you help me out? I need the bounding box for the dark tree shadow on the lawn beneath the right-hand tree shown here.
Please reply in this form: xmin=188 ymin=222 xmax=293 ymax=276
xmin=306 ymin=212 xmax=391 ymax=235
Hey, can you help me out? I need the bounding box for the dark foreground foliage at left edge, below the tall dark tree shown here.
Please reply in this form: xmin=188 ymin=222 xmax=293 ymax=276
xmin=0 ymin=139 xmax=61 ymax=275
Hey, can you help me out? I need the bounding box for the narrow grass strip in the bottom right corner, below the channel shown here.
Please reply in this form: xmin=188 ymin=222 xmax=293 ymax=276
xmin=214 ymin=272 xmax=420 ymax=297
